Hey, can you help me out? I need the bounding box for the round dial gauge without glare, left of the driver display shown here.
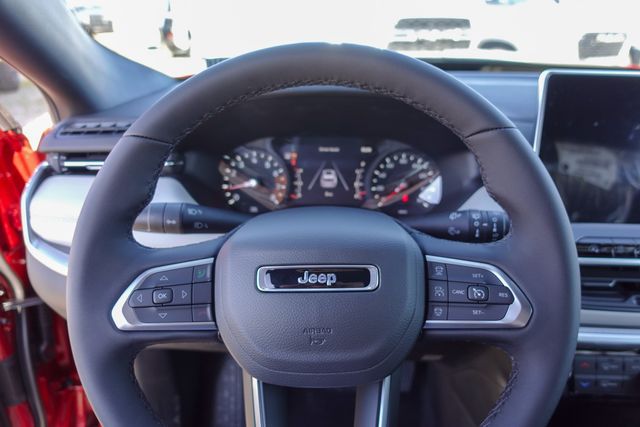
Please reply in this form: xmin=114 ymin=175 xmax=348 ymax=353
xmin=218 ymin=147 xmax=289 ymax=213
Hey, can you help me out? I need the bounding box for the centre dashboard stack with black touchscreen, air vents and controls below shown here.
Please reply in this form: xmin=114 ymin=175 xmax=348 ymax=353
xmin=535 ymin=70 xmax=640 ymax=398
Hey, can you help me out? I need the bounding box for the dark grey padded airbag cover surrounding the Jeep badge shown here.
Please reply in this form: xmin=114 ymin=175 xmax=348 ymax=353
xmin=215 ymin=207 xmax=425 ymax=387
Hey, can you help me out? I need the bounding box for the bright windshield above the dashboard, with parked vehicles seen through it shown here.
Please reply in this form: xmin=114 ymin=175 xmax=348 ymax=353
xmin=67 ymin=0 xmax=640 ymax=76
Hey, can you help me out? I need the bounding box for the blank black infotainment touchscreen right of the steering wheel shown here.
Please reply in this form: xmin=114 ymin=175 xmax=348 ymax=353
xmin=536 ymin=72 xmax=640 ymax=223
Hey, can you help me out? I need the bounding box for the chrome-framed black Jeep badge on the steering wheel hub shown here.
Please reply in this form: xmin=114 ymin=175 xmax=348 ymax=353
xmin=256 ymin=265 xmax=380 ymax=292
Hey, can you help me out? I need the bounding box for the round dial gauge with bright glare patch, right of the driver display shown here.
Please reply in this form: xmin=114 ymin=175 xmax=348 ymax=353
xmin=364 ymin=150 xmax=442 ymax=216
